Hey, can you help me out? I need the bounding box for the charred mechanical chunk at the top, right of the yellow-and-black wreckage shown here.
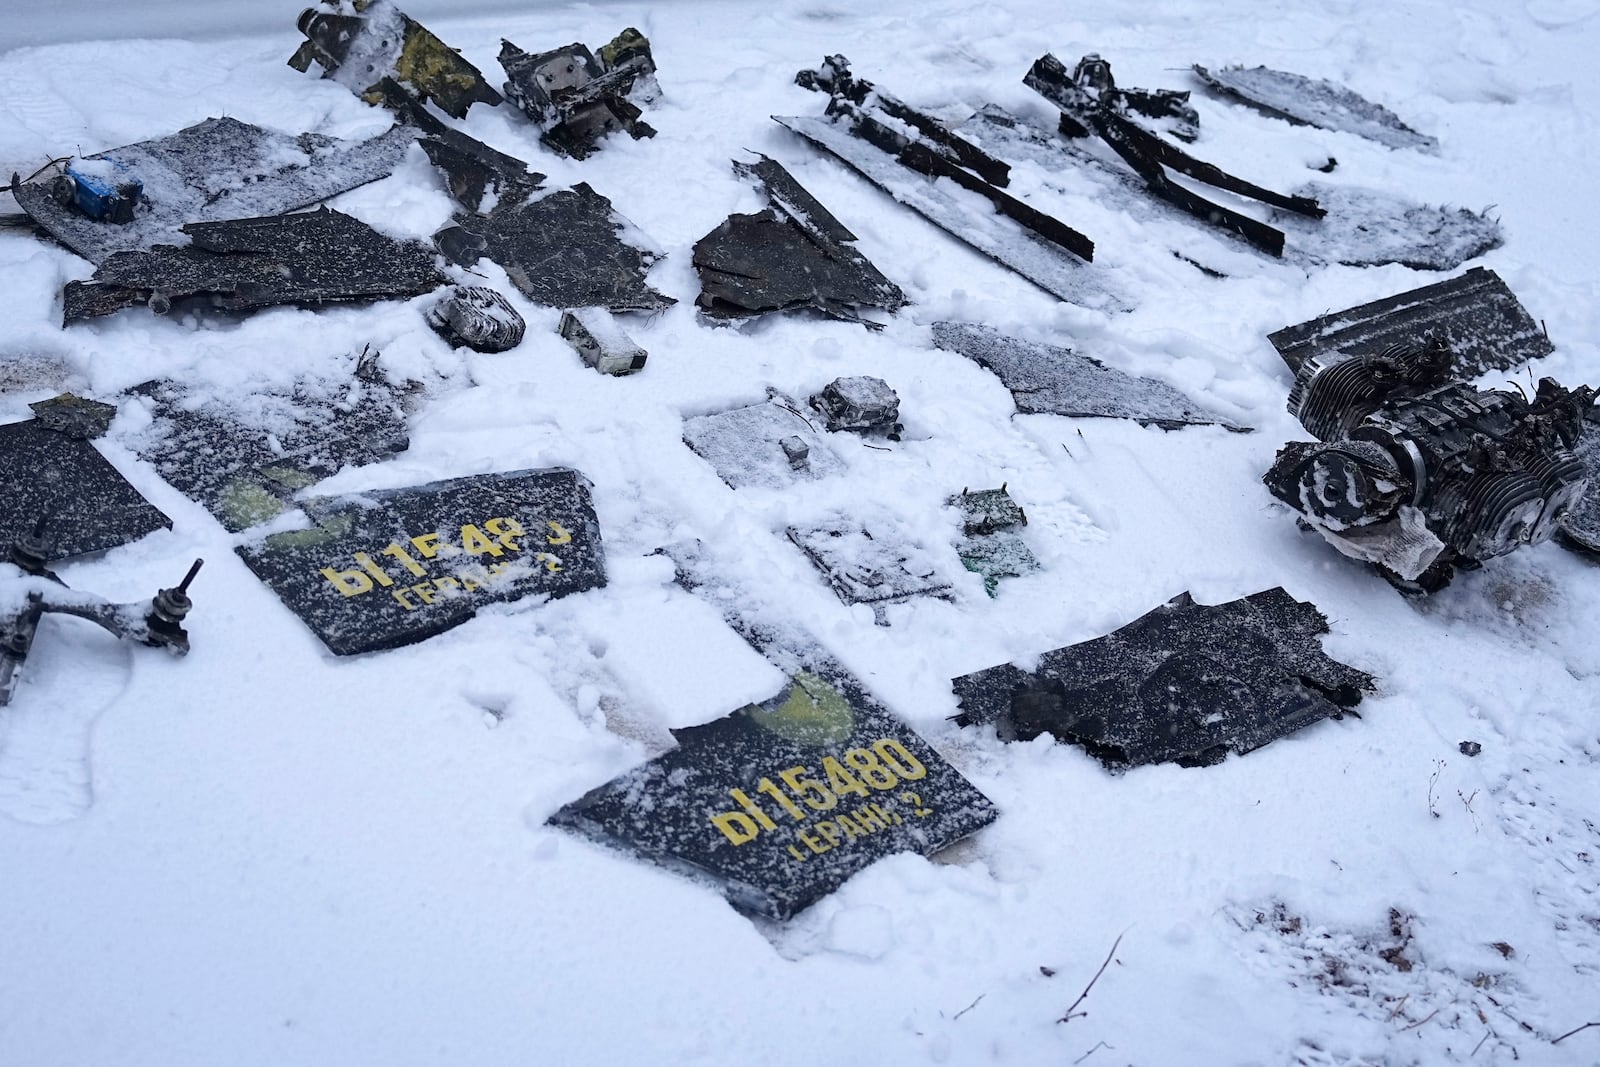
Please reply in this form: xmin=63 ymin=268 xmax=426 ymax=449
xmin=499 ymin=27 xmax=659 ymax=160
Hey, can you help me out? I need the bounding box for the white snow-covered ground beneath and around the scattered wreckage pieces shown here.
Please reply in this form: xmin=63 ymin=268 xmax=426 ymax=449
xmin=0 ymin=0 xmax=1600 ymax=1065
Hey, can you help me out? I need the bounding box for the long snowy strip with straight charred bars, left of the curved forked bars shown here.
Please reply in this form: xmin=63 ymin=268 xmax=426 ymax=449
xmin=776 ymin=56 xmax=1123 ymax=309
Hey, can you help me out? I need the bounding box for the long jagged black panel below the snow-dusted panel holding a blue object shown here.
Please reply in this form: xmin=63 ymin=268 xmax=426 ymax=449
xmin=62 ymin=208 xmax=448 ymax=323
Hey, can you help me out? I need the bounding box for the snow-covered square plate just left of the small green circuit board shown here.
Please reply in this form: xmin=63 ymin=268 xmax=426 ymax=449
xmin=789 ymin=518 xmax=952 ymax=625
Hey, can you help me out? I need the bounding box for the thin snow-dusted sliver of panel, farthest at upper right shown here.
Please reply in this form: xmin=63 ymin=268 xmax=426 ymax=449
xmin=1194 ymin=64 xmax=1438 ymax=152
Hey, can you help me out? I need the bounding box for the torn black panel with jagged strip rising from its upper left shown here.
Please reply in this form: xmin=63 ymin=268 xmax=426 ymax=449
xmin=421 ymin=122 xmax=677 ymax=312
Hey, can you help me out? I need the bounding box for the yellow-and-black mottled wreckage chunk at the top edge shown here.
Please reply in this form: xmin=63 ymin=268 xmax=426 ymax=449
xmin=290 ymin=0 xmax=501 ymax=118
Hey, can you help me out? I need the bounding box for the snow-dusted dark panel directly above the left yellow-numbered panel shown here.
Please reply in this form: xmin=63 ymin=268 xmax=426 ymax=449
xmin=128 ymin=352 xmax=410 ymax=533
